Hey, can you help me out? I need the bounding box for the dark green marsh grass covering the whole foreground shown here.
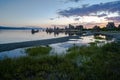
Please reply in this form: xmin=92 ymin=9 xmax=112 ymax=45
xmin=0 ymin=43 xmax=120 ymax=80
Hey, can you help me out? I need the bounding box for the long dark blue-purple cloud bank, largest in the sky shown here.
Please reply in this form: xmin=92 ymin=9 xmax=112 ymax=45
xmin=58 ymin=1 xmax=120 ymax=17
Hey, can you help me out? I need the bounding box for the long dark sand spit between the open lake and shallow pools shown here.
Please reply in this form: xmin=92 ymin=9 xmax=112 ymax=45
xmin=0 ymin=36 xmax=79 ymax=52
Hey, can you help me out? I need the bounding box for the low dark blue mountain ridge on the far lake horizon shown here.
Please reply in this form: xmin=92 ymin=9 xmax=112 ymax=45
xmin=0 ymin=26 xmax=43 ymax=30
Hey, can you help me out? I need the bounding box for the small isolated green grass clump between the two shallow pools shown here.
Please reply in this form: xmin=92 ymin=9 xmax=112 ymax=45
xmin=26 ymin=46 xmax=51 ymax=56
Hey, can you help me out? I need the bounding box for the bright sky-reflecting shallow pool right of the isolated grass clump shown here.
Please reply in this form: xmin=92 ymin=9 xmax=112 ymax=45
xmin=50 ymin=35 xmax=114 ymax=55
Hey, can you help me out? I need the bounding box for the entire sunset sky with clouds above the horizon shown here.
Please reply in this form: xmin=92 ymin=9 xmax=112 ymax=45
xmin=0 ymin=0 xmax=120 ymax=28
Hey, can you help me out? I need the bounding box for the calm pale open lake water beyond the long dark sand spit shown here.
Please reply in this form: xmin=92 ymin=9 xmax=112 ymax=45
xmin=0 ymin=30 xmax=67 ymax=44
